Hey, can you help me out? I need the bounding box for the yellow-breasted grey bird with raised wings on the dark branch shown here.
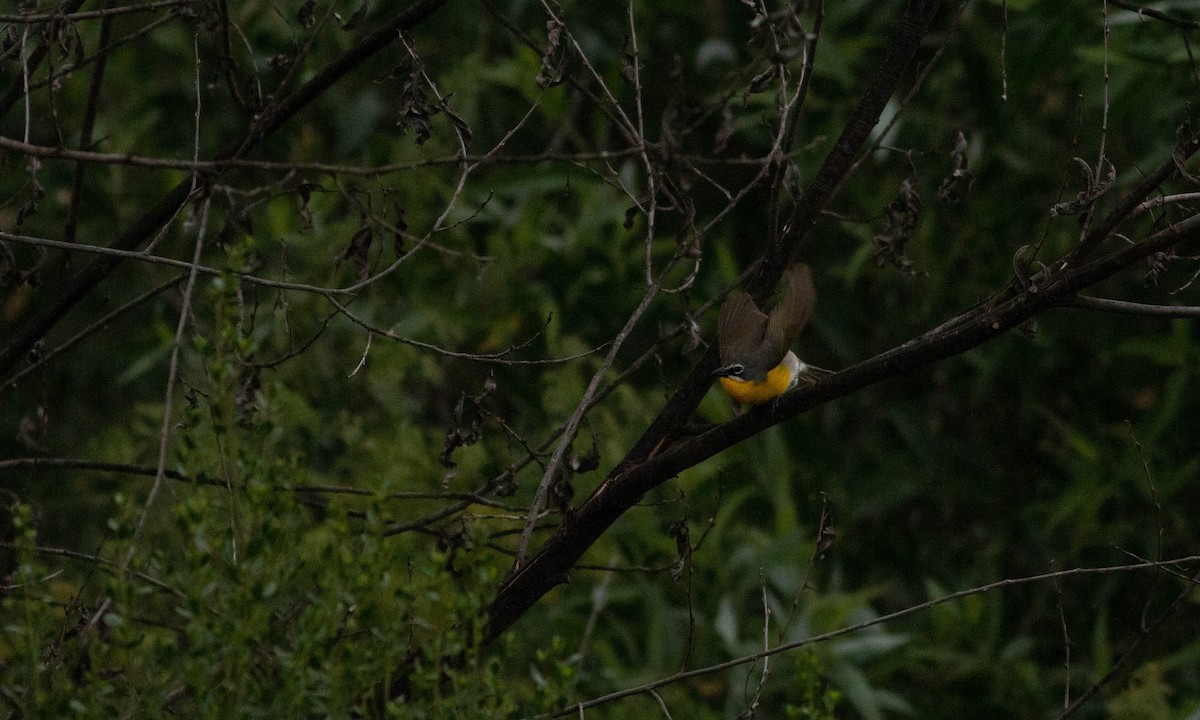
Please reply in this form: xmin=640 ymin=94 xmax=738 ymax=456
xmin=713 ymin=263 xmax=829 ymax=406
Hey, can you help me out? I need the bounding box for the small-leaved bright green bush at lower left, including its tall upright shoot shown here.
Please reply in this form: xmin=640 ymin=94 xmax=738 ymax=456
xmin=4 ymin=243 xmax=525 ymax=718
